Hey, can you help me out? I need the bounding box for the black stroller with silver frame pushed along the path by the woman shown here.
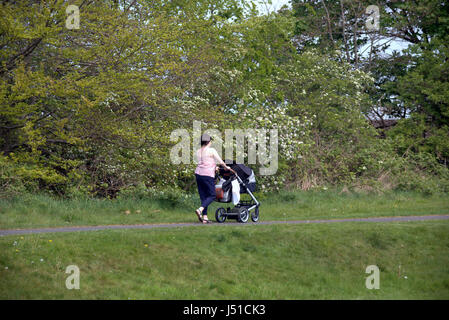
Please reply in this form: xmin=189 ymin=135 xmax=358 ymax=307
xmin=215 ymin=161 xmax=260 ymax=223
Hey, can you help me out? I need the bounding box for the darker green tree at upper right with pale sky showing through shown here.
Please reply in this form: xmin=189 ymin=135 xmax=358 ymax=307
xmin=293 ymin=0 xmax=449 ymax=168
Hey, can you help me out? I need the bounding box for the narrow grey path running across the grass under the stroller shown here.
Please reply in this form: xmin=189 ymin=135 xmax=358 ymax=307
xmin=0 ymin=214 xmax=449 ymax=236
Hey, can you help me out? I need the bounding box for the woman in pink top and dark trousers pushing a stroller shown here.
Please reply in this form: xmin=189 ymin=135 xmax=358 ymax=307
xmin=195 ymin=134 xmax=230 ymax=224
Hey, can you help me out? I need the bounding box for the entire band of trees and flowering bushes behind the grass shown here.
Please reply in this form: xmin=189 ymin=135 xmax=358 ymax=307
xmin=0 ymin=0 xmax=449 ymax=198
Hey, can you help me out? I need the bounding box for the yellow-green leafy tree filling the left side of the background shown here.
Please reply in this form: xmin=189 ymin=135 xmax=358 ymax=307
xmin=0 ymin=1 xmax=245 ymax=196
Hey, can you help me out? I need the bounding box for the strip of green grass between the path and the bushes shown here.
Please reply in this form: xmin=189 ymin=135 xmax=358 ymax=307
xmin=0 ymin=190 xmax=449 ymax=229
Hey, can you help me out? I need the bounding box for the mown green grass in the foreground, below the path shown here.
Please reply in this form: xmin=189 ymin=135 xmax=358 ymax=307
xmin=0 ymin=221 xmax=449 ymax=300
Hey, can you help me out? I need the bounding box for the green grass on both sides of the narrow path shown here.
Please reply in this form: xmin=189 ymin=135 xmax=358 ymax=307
xmin=0 ymin=190 xmax=449 ymax=300
